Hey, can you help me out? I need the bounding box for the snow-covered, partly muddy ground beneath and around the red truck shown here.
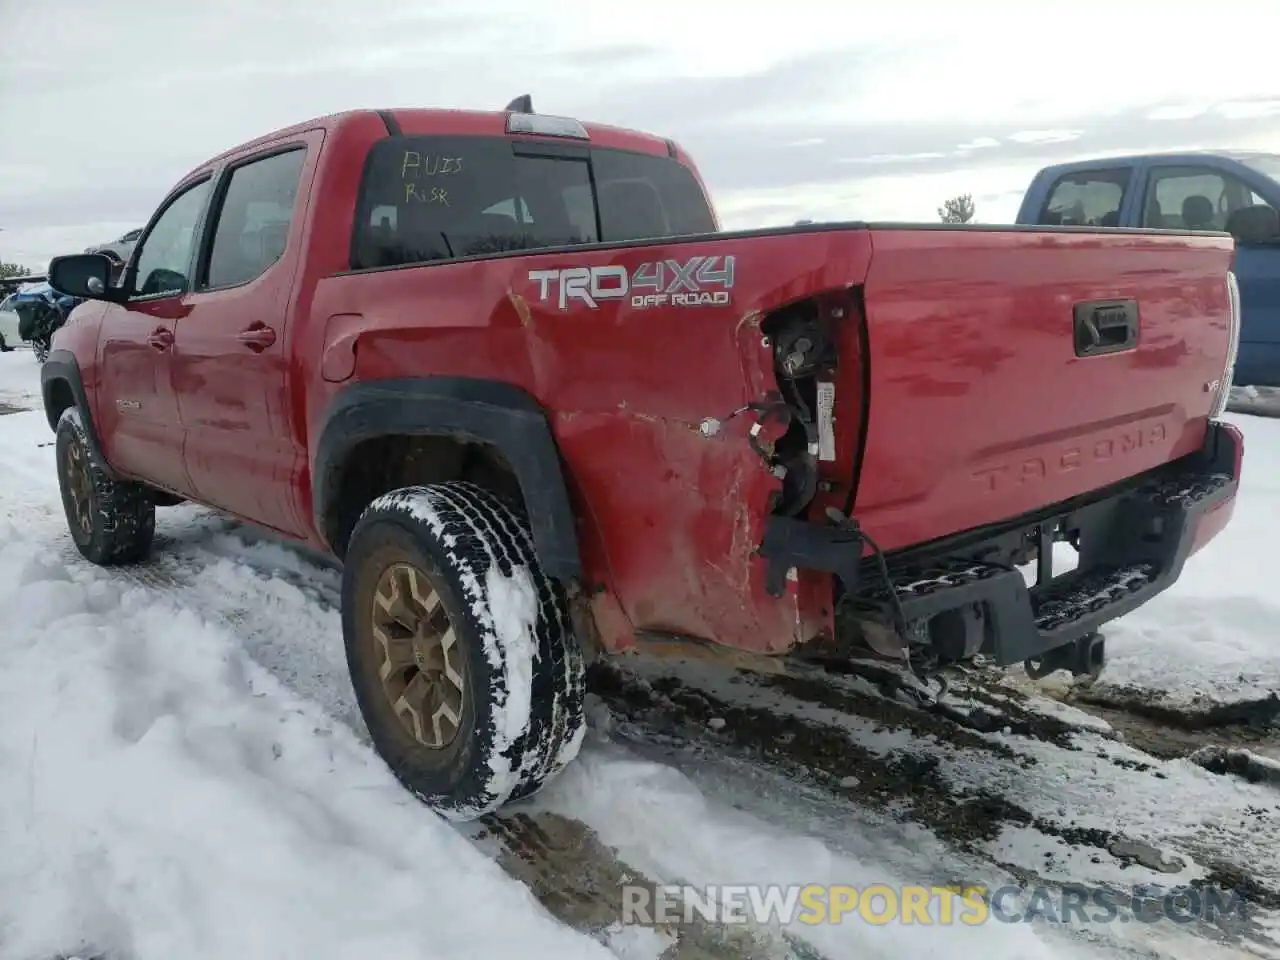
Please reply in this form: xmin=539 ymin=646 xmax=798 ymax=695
xmin=0 ymin=352 xmax=1280 ymax=960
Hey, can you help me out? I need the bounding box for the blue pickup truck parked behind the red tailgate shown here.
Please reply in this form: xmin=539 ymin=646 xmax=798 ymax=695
xmin=1018 ymin=151 xmax=1280 ymax=387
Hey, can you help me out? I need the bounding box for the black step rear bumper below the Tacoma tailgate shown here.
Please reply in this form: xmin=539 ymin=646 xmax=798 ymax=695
xmin=757 ymin=422 xmax=1244 ymax=664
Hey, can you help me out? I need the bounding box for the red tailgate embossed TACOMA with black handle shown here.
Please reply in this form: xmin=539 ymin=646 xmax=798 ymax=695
xmin=856 ymin=228 xmax=1233 ymax=549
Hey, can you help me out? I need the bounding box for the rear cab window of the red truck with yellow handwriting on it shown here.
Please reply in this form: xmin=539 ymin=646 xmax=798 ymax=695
xmin=351 ymin=137 xmax=716 ymax=270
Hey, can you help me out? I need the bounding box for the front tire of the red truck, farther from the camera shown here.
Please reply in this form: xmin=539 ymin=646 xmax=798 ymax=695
xmin=54 ymin=407 xmax=156 ymax=567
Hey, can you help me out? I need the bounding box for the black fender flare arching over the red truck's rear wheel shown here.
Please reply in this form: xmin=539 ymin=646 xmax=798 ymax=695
xmin=311 ymin=376 xmax=581 ymax=581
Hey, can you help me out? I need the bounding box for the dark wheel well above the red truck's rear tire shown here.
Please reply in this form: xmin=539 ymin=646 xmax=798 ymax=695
xmin=335 ymin=435 xmax=527 ymax=557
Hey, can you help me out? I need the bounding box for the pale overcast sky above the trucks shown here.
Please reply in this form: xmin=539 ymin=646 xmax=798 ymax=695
xmin=0 ymin=0 xmax=1280 ymax=269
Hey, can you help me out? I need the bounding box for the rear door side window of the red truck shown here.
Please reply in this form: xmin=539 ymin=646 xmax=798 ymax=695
xmin=201 ymin=150 xmax=307 ymax=287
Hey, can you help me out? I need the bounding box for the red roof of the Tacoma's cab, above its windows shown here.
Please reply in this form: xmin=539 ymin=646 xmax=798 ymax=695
xmin=183 ymin=108 xmax=687 ymax=179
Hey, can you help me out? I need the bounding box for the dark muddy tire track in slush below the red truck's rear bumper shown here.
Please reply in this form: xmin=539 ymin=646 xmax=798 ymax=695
xmin=593 ymin=657 xmax=1280 ymax=950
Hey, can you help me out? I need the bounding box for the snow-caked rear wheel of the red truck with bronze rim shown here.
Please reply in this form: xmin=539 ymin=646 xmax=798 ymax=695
xmin=342 ymin=483 xmax=585 ymax=819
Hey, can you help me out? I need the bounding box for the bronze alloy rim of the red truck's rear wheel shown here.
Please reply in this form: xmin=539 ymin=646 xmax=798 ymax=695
xmin=370 ymin=562 xmax=467 ymax=750
